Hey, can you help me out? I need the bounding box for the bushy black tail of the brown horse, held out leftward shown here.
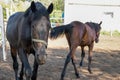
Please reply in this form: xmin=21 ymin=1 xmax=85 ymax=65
xmin=50 ymin=24 xmax=72 ymax=39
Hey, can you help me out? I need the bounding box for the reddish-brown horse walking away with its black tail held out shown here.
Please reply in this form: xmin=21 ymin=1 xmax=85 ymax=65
xmin=50 ymin=21 xmax=102 ymax=80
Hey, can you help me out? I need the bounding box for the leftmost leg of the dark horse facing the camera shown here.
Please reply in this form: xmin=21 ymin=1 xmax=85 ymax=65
xmin=10 ymin=46 xmax=19 ymax=80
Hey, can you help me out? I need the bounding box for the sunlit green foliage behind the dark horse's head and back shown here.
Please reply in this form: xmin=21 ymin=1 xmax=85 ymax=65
xmin=0 ymin=0 xmax=64 ymax=22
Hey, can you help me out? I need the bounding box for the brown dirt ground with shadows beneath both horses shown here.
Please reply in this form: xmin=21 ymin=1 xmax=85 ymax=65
xmin=0 ymin=35 xmax=120 ymax=80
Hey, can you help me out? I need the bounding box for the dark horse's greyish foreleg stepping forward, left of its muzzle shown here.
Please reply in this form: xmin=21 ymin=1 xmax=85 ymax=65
xmin=18 ymin=48 xmax=32 ymax=80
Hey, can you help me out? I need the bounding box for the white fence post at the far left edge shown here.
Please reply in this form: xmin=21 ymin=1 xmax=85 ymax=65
xmin=0 ymin=5 xmax=6 ymax=61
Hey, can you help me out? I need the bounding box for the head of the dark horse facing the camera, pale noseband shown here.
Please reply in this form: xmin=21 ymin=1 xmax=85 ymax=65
xmin=25 ymin=1 xmax=53 ymax=64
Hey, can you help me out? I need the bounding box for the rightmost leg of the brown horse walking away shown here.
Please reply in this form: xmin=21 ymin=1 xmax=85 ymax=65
xmin=88 ymin=43 xmax=94 ymax=74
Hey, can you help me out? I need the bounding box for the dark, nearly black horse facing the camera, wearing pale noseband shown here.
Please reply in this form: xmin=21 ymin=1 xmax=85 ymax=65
xmin=6 ymin=1 xmax=53 ymax=80
